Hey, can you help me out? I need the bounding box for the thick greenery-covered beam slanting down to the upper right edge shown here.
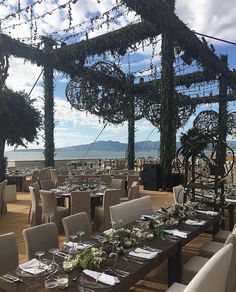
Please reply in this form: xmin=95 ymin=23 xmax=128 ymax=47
xmin=124 ymin=0 xmax=236 ymax=86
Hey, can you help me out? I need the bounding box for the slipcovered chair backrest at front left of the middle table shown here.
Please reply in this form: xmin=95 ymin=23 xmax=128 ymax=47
xmin=40 ymin=190 xmax=57 ymax=223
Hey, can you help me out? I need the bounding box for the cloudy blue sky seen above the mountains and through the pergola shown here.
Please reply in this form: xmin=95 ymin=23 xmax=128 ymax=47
xmin=0 ymin=0 xmax=236 ymax=150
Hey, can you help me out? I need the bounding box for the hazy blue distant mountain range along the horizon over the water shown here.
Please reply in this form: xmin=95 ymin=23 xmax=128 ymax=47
xmin=8 ymin=140 xmax=236 ymax=152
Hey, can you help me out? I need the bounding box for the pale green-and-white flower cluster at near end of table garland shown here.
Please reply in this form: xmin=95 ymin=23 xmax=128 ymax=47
xmin=67 ymin=247 xmax=107 ymax=269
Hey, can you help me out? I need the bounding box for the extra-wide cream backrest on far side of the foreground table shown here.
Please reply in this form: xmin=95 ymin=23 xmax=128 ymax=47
xmin=109 ymin=196 xmax=153 ymax=229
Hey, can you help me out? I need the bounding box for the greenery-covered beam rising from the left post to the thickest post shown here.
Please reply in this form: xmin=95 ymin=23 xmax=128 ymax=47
xmin=53 ymin=21 xmax=161 ymax=64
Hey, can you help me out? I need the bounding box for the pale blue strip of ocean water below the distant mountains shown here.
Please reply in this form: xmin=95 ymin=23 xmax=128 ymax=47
xmin=5 ymin=150 xmax=159 ymax=161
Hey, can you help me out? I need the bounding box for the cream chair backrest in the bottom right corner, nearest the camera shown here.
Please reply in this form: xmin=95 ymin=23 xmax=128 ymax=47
xmin=184 ymin=244 xmax=233 ymax=292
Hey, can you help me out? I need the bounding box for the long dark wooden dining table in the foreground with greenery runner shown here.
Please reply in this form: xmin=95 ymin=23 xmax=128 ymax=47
xmin=0 ymin=215 xmax=220 ymax=292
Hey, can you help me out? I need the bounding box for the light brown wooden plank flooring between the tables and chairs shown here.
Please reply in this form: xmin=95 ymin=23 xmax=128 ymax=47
xmin=0 ymin=190 xmax=210 ymax=292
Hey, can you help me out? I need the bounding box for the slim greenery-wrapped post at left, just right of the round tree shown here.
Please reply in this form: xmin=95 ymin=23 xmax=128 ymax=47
xmin=43 ymin=38 xmax=55 ymax=167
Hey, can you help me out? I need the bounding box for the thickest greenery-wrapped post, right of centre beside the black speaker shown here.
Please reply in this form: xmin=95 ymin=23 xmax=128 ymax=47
xmin=160 ymin=0 xmax=177 ymax=188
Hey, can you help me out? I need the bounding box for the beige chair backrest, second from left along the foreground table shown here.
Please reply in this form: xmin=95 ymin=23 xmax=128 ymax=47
xmin=23 ymin=222 xmax=59 ymax=260
